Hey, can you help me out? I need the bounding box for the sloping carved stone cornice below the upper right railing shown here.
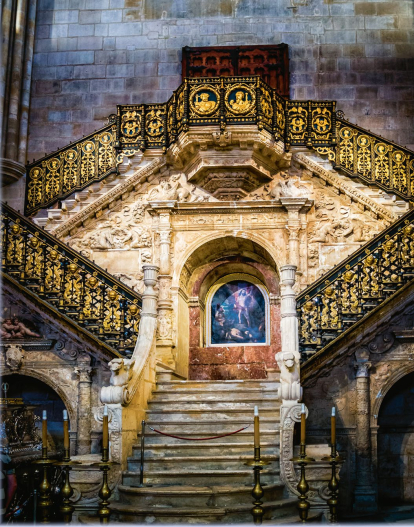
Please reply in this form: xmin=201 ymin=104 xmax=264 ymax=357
xmin=292 ymin=153 xmax=398 ymax=223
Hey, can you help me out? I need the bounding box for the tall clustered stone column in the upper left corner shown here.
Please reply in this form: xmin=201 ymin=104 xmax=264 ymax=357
xmin=0 ymin=0 xmax=37 ymax=184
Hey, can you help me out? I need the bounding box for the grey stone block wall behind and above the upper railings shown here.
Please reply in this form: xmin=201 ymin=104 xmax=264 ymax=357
xmin=28 ymin=0 xmax=414 ymax=160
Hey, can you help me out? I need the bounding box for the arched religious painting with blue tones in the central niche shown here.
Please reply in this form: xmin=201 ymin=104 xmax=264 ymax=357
xmin=210 ymin=280 xmax=266 ymax=345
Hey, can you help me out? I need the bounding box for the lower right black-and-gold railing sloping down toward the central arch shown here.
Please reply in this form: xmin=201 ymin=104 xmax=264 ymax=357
xmin=297 ymin=210 xmax=414 ymax=360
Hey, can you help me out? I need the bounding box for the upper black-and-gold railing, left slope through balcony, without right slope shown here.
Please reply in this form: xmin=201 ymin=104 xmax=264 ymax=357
xmin=25 ymin=76 xmax=335 ymax=215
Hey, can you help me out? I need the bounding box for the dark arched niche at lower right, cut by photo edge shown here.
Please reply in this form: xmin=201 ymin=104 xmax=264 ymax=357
xmin=377 ymin=372 xmax=414 ymax=505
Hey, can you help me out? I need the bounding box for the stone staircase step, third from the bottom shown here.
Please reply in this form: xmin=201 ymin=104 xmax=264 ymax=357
xmin=122 ymin=470 xmax=279 ymax=487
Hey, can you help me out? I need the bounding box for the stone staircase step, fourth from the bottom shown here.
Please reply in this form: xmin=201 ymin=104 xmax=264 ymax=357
xmin=128 ymin=456 xmax=279 ymax=473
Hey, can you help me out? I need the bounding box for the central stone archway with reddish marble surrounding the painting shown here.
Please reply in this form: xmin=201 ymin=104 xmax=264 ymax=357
xmin=177 ymin=235 xmax=280 ymax=380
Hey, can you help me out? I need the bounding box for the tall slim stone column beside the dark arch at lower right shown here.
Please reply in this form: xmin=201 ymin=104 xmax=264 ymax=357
xmin=354 ymin=353 xmax=377 ymax=513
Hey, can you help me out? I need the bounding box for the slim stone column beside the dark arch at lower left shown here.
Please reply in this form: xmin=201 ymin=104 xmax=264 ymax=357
xmin=75 ymin=353 xmax=92 ymax=455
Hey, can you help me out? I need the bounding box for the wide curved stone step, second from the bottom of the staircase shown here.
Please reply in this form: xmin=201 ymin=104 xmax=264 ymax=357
xmin=118 ymin=483 xmax=284 ymax=508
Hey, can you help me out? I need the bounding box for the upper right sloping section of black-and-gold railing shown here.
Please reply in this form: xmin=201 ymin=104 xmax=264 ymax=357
xmin=316 ymin=112 xmax=414 ymax=201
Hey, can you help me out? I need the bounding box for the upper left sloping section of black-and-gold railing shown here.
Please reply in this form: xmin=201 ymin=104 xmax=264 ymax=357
xmin=25 ymin=116 xmax=116 ymax=215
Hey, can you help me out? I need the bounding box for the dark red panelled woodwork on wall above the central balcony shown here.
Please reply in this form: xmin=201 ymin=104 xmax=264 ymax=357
xmin=183 ymin=44 xmax=289 ymax=97
